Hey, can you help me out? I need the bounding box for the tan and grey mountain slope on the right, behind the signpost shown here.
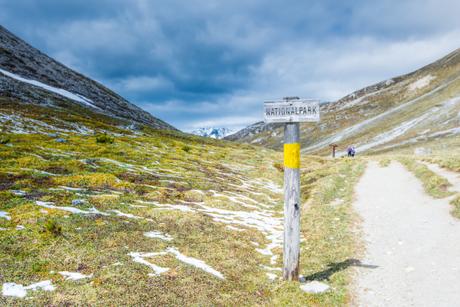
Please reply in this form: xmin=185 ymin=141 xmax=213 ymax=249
xmin=228 ymin=49 xmax=460 ymax=154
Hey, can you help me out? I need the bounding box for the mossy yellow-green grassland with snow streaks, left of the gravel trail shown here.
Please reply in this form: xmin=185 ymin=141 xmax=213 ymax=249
xmin=0 ymin=98 xmax=364 ymax=306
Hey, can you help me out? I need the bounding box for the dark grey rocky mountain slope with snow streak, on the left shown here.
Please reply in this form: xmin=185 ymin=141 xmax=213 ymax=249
xmin=0 ymin=26 xmax=175 ymax=129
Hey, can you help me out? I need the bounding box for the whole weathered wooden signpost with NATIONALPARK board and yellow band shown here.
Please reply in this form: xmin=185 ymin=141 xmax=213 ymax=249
xmin=264 ymin=97 xmax=319 ymax=281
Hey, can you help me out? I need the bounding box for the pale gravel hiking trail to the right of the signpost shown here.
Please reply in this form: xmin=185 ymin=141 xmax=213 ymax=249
xmin=355 ymin=162 xmax=460 ymax=306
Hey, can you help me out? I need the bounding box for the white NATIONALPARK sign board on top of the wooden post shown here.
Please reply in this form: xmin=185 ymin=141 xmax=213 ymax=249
xmin=264 ymin=100 xmax=319 ymax=123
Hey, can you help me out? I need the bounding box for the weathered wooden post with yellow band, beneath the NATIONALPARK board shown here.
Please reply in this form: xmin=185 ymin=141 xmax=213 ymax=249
xmin=283 ymin=123 xmax=300 ymax=281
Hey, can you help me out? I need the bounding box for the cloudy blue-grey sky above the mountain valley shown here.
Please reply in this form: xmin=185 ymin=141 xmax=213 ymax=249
xmin=0 ymin=0 xmax=460 ymax=131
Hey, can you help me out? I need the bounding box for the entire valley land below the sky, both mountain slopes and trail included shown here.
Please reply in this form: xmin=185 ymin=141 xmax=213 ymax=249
xmin=0 ymin=22 xmax=460 ymax=306
